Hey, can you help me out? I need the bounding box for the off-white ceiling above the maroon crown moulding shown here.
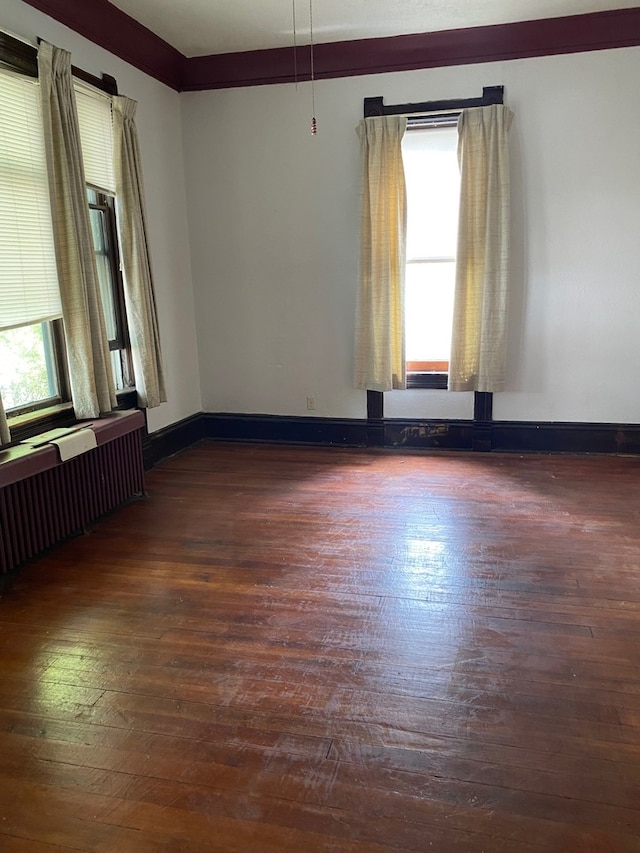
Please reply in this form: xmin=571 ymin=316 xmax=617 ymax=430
xmin=110 ymin=0 xmax=638 ymax=56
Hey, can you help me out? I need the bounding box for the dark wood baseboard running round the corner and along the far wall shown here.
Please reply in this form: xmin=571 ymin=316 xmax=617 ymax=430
xmin=143 ymin=412 xmax=640 ymax=470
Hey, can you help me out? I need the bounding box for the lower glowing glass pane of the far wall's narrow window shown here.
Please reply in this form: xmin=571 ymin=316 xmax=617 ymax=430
xmin=405 ymin=261 xmax=456 ymax=361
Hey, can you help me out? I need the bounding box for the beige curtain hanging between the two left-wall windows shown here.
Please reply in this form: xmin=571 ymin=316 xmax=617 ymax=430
xmin=38 ymin=42 xmax=117 ymax=418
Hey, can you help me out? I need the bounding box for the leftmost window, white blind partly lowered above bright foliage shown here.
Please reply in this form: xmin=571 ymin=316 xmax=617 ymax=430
xmin=0 ymin=63 xmax=69 ymax=416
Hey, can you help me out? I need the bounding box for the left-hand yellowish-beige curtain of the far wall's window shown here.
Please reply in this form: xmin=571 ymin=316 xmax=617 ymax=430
xmin=354 ymin=116 xmax=407 ymax=391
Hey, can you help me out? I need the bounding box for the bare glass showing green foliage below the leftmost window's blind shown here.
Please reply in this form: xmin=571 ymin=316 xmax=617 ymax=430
xmin=0 ymin=323 xmax=58 ymax=409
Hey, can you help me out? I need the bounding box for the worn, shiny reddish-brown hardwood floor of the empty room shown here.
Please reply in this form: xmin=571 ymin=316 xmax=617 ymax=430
xmin=0 ymin=444 xmax=640 ymax=853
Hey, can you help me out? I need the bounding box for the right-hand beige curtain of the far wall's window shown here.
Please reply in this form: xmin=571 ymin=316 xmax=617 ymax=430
xmin=449 ymin=104 xmax=513 ymax=391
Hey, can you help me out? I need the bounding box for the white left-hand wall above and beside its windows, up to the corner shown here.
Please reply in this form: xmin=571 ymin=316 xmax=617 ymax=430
xmin=0 ymin=0 xmax=202 ymax=432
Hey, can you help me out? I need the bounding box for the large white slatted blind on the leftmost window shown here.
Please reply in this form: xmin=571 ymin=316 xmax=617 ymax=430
xmin=0 ymin=68 xmax=62 ymax=329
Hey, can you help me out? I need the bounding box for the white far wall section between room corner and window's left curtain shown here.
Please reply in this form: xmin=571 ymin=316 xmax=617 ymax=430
xmin=183 ymin=84 xmax=365 ymax=417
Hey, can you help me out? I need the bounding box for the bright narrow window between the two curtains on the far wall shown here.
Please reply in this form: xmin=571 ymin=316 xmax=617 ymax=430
xmin=402 ymin=117 xmax=460 ymax=388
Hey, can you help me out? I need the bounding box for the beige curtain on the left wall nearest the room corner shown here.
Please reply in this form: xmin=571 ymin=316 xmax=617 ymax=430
xmin=113 ymin=96 xmax=167 ymax=408
